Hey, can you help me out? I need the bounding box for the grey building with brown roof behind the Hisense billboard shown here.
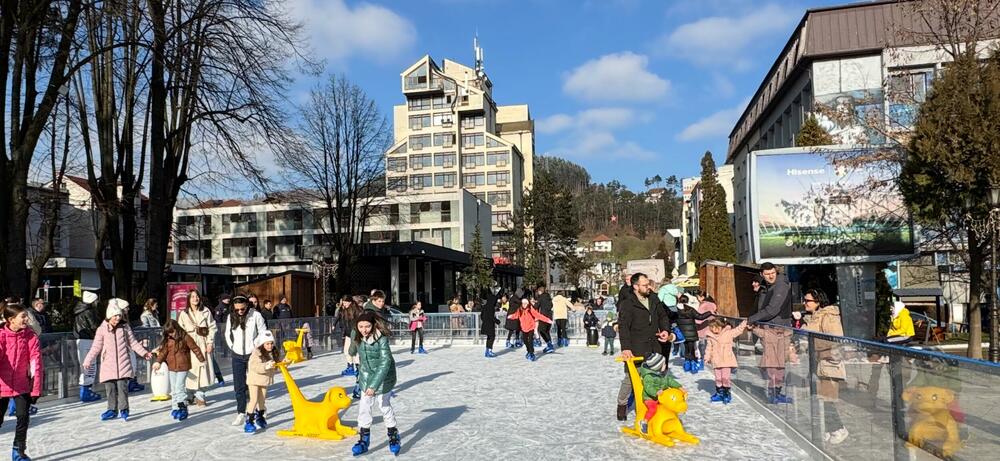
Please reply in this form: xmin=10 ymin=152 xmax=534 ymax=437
xmin=726 ymin=1 xmax=1000 ymax=337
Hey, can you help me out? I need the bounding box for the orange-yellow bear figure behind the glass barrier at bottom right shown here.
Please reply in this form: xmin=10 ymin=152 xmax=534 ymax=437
xmin=903 ymin=386 xmax=962 ymax=457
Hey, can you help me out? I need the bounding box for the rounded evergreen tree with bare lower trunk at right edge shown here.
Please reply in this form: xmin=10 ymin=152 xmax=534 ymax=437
xmin=899 ymin=51 xmax=1000 ymax=358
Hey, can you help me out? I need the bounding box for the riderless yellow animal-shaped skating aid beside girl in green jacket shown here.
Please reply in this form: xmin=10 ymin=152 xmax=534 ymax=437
xmin=275 ymin=362 xmax=358 ymax=440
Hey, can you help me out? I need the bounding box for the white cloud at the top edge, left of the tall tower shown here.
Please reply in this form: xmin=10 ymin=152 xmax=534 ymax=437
xmin=289 ymin=0 xmax=417 ymax=62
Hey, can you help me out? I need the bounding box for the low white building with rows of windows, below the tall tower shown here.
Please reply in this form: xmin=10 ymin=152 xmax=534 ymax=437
xmin=174 ymin=190 xmax=492 ymax=310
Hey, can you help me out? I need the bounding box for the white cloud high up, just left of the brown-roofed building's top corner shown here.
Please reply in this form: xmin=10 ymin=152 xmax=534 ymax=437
xmin=654 ymin=4 xmax=796 ymax=70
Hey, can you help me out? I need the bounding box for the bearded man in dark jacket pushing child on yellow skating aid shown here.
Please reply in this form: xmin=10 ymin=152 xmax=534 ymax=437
xmin=617 ymin=272 xmax=673 ymax=421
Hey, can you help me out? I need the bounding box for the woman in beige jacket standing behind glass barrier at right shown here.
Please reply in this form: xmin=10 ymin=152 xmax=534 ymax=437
xmin=802 ymin=289 xmax=847 ymax=445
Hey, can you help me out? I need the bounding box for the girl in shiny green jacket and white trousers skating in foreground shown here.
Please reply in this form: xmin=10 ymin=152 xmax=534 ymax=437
xmin=351 ymin=311 xmax=400 ymax=456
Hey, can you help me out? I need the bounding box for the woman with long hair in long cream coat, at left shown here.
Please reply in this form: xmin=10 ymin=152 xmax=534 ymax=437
xmin=177 ymin=290 xmax=216 ymax=407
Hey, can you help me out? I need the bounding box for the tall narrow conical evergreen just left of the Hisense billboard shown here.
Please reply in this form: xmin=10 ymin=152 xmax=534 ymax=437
xmin=692 ymin=152 xmax=736 ymax=263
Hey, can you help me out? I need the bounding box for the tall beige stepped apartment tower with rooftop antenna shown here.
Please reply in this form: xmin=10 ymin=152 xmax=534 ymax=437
xmin=386 ymin=45 xmax=535 ymax=263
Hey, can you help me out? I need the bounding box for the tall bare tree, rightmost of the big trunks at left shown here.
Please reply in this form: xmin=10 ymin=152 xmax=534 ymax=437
xmin=146 ymin=0 xmax=299 ymax=312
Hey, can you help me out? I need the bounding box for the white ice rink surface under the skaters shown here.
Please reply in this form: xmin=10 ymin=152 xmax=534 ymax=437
xmin=17 ymin=345 xmax=808 ymax=461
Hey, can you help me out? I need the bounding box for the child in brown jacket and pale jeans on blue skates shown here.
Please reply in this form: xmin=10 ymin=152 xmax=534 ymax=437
xmin=153 ymin=319 xmax=205 ymax=421
